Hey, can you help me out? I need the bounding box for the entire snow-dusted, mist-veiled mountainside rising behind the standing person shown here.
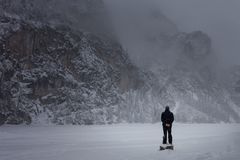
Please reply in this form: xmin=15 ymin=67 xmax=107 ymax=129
xmin=0 ymin=0 xmax=240 ymax=124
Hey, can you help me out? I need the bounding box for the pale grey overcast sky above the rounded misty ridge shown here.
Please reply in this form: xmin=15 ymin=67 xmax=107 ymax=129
xmin=159 ymin=0 xmax=240 ymax=64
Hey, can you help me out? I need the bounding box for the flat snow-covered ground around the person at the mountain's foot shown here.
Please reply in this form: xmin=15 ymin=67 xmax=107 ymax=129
xmin=0 ymin=124 xmax=240 ymax=160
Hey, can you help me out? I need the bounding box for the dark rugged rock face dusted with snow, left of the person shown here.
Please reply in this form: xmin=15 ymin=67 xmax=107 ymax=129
xmin=0 ymin=17 xmax=146 ymax=124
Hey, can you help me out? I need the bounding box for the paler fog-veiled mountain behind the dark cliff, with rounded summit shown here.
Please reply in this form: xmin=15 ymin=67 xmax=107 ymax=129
xmin=106 ymin=0 xmax=240 ymax=122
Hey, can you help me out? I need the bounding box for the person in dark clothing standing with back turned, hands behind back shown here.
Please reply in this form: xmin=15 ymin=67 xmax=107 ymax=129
xmin=161 ymin=106 xmax=174 ymax=145
